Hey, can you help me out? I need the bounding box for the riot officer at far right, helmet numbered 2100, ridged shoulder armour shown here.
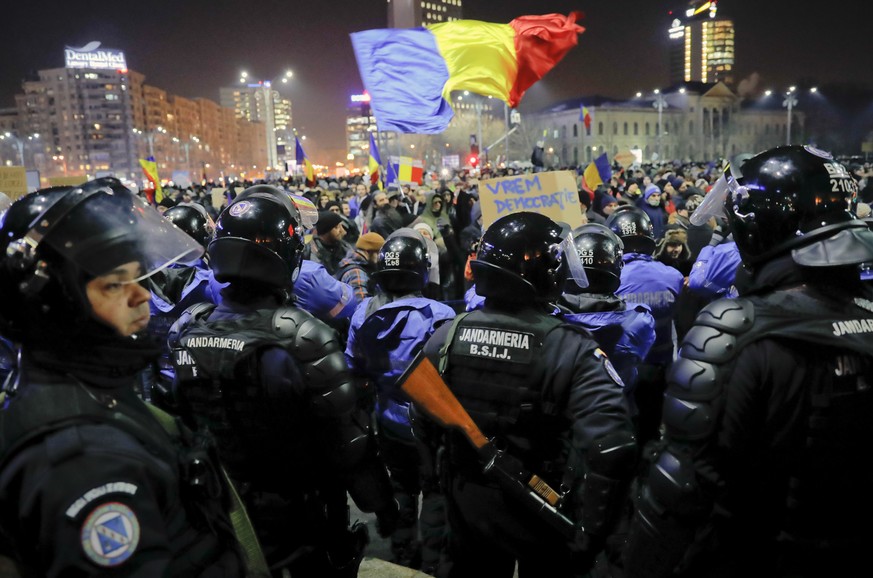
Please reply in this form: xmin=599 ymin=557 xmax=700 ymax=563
xmin=625 ymin=146 xmax=873 ymax=577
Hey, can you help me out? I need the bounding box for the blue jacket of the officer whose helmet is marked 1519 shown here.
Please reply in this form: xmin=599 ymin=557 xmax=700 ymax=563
xmin=616 ymin=253 xmax=685 ymax=365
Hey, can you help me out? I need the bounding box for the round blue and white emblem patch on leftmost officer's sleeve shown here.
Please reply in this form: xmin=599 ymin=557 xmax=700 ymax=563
xmin=81 ymin=502 xmax=139 ymax=567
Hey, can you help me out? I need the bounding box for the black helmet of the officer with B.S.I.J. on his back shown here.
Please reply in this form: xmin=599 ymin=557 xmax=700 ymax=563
xmin=470 ymin=212 xmax=588 ymax=303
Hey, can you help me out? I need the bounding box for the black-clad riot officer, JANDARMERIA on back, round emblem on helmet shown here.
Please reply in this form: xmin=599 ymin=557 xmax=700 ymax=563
xmin=170 ymin=185 xmax=397 ymax=576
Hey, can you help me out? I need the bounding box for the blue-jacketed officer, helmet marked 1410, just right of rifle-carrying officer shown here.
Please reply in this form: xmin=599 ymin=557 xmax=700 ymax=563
xmin=558 ymin=223 xmax=655 ymax=415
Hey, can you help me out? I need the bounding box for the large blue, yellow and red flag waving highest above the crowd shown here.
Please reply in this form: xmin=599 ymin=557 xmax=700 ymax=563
xmin=351 ymin=12 xmax=585 ymax=134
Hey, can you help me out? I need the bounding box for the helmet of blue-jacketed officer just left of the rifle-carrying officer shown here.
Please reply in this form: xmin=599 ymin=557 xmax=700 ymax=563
xmin=373 ymin=227 xmax=431 ymax=295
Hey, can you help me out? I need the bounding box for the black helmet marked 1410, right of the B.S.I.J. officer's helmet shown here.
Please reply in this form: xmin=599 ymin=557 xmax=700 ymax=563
xmin=566 ymin=223 xmax=624 ymax=295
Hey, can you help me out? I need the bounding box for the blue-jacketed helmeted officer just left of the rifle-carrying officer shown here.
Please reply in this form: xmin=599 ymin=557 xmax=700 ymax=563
xmin=346 ymin=227 xmax=455 ymax=574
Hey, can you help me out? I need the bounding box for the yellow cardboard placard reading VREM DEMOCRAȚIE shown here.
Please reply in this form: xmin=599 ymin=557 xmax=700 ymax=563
xmin=479 ymin=171 xmax=582 ymax=229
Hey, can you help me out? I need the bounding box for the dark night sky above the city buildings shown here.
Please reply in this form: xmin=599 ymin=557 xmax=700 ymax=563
xmin=0 ymin=0 xmax=873 ymax=162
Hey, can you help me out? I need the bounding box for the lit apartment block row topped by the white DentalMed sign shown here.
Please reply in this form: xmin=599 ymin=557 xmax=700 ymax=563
xmin=0 ymin=43 xmax=270 ymax=183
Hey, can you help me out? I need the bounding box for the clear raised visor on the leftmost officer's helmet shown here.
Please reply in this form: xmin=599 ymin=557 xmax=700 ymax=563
xmin=42 ymin=186 xmax=203 ymax=283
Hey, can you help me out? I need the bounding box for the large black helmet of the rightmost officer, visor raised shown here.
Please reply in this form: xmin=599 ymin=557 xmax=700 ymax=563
xmin=694 ymin=145 xmax=873 ymax=267
